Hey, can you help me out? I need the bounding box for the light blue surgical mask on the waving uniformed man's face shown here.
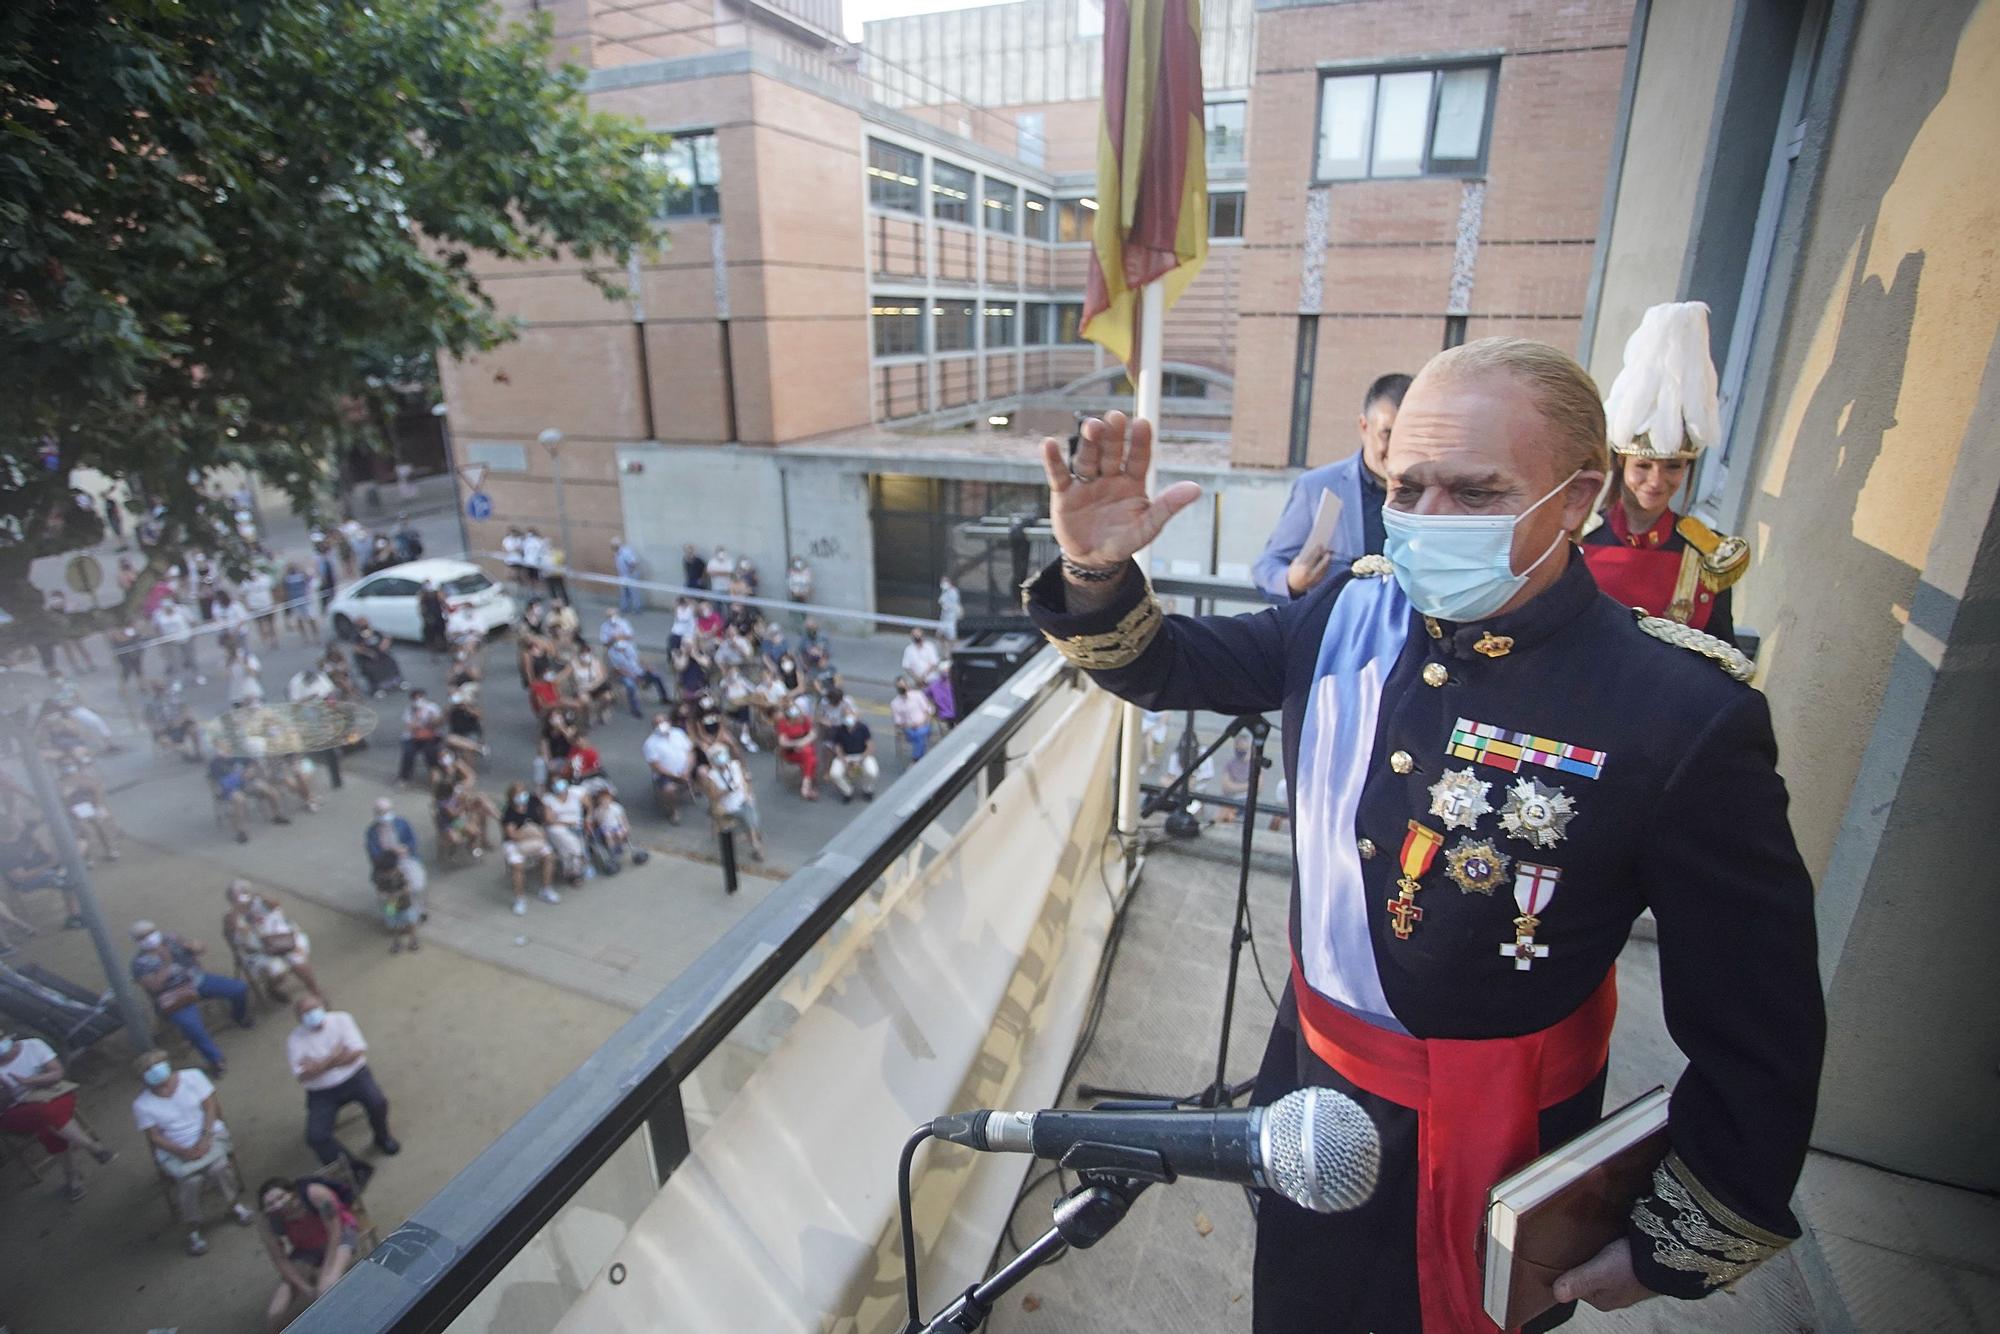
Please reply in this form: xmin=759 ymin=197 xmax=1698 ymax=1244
xmin=1382 ymin=468 xmax=1582 ymax=620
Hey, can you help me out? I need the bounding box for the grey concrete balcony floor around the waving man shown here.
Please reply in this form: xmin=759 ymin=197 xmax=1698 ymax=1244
xmin=988 ymin=840 xmax=2000 ymax=1334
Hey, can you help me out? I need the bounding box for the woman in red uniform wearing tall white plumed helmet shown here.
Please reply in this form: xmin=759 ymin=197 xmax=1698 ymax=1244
xmin=1582 ymin=302 xmax=1750 ymax=640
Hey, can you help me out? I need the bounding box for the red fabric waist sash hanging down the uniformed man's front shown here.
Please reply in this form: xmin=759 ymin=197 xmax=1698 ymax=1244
xmin=1292 ymin=958 xmax=1618 ymax=1334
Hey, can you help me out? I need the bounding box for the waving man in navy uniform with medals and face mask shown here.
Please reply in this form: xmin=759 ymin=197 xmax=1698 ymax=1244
xmin=1024 ymin=338 xmax=1826 ymax=1334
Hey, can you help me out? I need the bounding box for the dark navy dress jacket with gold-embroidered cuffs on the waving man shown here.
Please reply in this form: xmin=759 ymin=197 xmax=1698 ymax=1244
xmin=1026 ymin=550 xmax=1824 ymax=1296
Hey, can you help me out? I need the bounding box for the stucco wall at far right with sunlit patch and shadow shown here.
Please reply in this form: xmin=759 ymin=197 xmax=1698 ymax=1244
xmin=1738 ymin=0 xmax=2000 ymax=1188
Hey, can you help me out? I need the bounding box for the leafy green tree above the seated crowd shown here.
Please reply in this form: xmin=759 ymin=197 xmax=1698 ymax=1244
xmin=0 ymin=0 xmax=664 ymax=648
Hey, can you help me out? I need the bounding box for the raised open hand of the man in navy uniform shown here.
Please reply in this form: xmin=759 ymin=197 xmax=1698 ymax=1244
xmin=1042 ymin=412 xmax=1202 ymax=566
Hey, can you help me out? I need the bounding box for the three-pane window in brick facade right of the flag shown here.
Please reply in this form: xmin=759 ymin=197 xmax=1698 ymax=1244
xmin=1318 ymin=64 xmax=1494 ymax=180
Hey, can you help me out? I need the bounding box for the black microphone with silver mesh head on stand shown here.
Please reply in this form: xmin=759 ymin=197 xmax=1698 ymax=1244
xmin=930 ymin=1088 xmax=1382 ymax=1214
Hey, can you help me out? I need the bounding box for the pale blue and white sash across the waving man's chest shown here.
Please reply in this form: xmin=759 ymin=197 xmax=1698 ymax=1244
xmin=1296 ymin=578 xmax=1410 ymax=1032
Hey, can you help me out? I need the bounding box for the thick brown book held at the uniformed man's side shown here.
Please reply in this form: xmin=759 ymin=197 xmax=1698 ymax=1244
xmin=1484 ymin=1088 xmax=1670 ymax=1330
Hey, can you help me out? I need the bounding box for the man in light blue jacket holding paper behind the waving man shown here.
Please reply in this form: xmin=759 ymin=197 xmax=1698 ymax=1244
xmin=1250 ymin=374 xmax=1410 ymax=602
